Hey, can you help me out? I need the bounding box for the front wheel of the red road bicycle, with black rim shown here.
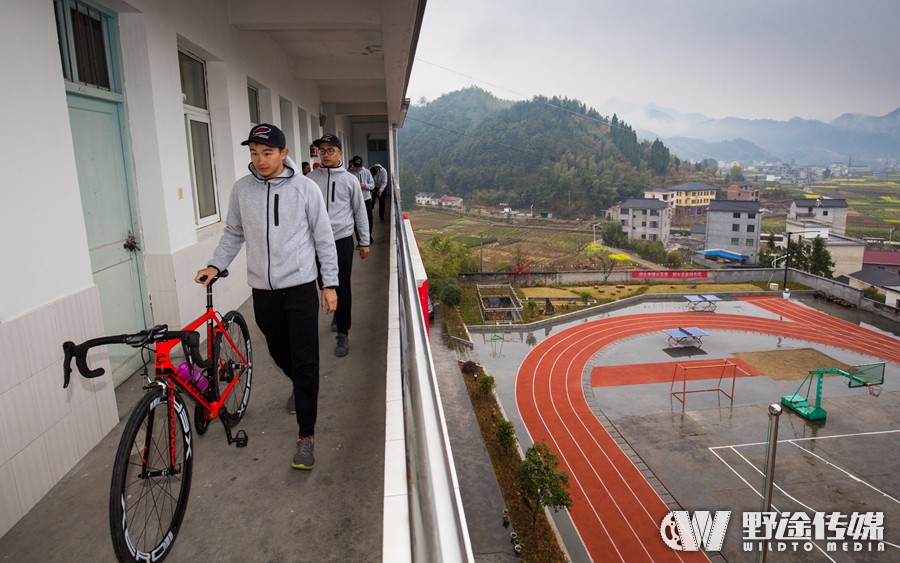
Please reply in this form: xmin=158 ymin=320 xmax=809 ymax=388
xmin=109 ymin=389 xmax=194 ymax=561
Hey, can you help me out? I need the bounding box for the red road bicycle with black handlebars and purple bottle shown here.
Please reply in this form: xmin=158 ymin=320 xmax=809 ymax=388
xmin=63 ymin=270 xmax=253 ymax=561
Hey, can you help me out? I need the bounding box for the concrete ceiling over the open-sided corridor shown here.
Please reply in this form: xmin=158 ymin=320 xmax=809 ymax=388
xmin=228 ymin=0 xmax=426 ymax=124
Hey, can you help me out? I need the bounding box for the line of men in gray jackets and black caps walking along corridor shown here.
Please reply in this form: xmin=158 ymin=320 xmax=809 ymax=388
xmin=195 ymin=123 xmax=388 ymax=470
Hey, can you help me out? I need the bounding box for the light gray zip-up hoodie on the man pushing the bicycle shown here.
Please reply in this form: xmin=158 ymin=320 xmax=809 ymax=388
xmin=209 ymin=157 xmax=338 ymax=289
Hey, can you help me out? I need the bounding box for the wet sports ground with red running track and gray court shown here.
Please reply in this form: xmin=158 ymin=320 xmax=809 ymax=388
xmin=470 ymin=297 xmax=900 ymax=562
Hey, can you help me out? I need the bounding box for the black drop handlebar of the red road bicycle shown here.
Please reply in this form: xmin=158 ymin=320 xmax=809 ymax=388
xmin=63 ymin=325 xmax=212 ymax=389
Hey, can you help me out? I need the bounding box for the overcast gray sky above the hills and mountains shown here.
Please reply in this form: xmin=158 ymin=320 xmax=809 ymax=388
xmin=407 ymin=0 xmax=900 ymax=121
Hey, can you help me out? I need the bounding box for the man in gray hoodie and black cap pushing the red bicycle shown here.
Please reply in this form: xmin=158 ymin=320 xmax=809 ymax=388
xmin=194 ymin=123 xmax=338 ymax=470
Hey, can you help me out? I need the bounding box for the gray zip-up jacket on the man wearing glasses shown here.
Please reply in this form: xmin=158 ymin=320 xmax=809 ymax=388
xmin=306 ymin=161 xmax=369 ymax=246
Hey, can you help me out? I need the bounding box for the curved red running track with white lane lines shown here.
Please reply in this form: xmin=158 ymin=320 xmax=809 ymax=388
xmin=516 ymin=297 xmax=900 ymax=563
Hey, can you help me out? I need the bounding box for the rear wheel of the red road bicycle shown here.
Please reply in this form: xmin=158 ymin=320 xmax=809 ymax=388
xmin=213 ymin=311 xmax=253 ymax=426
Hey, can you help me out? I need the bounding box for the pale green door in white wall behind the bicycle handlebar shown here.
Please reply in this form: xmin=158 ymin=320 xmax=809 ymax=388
xmin=67 ymin=93 xmax=149 ymax=385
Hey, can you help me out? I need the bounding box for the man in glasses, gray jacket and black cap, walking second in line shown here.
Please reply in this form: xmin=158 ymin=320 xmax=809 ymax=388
xmin=307 ymin=134 xmax=369 ymax=358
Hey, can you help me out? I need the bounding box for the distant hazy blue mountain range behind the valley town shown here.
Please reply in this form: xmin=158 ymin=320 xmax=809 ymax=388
xmin=597 ymin=99 xmax=900 ymax=166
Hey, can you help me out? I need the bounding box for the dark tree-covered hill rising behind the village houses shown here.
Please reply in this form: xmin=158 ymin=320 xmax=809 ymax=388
xmin=398 ymin=87 xmax=681 ymax=217
